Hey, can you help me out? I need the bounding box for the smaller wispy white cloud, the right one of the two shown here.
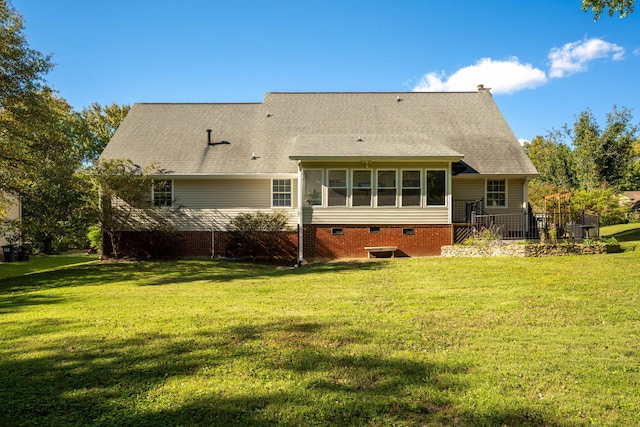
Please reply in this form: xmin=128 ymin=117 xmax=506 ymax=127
xmin=549 ymin=38 xmax=624 ymax=78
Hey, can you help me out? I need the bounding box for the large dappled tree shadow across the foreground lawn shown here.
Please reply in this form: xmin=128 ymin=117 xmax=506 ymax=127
xmin=0 ymin=317 xmax=568 ymax=426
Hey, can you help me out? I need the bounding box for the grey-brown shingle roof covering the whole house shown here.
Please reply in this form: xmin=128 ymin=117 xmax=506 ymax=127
xmin=102 ymin=90 xmax=537 ymax=175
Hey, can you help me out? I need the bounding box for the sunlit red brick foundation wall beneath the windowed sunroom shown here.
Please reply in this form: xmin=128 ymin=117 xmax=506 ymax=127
xmin=304 ymin=224 xmax=452 ymax=258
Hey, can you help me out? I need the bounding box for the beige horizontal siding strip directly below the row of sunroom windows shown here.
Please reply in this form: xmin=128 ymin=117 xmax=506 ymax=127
xmin=303 ymin=206 xmax=449 ymax=224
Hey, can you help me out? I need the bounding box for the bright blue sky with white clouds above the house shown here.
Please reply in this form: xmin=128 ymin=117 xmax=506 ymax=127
xmin=12 ymin=0 xmax=640 ymax=139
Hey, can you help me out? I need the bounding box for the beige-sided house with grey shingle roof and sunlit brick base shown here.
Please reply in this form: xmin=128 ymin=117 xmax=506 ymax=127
xmin=102 ymin=86 xmax=537 ymax=261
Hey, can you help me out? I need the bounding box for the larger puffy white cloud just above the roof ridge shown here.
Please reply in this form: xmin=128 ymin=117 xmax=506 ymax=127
xmin=413 ymin=57 xmax=547 ymax=94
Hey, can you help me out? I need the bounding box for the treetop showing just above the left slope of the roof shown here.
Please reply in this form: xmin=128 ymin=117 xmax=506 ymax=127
xmin=80 ymin=102 xmax=131 ymax=165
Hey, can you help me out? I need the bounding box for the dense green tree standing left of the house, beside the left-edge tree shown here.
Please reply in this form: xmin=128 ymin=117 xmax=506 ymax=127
xmin=15 ymin=91 xmax=95 ymax=253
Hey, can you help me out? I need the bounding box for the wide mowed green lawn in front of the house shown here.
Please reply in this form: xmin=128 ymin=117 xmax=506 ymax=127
xmin=0 ymin=242 xmax=640 ymax=426
